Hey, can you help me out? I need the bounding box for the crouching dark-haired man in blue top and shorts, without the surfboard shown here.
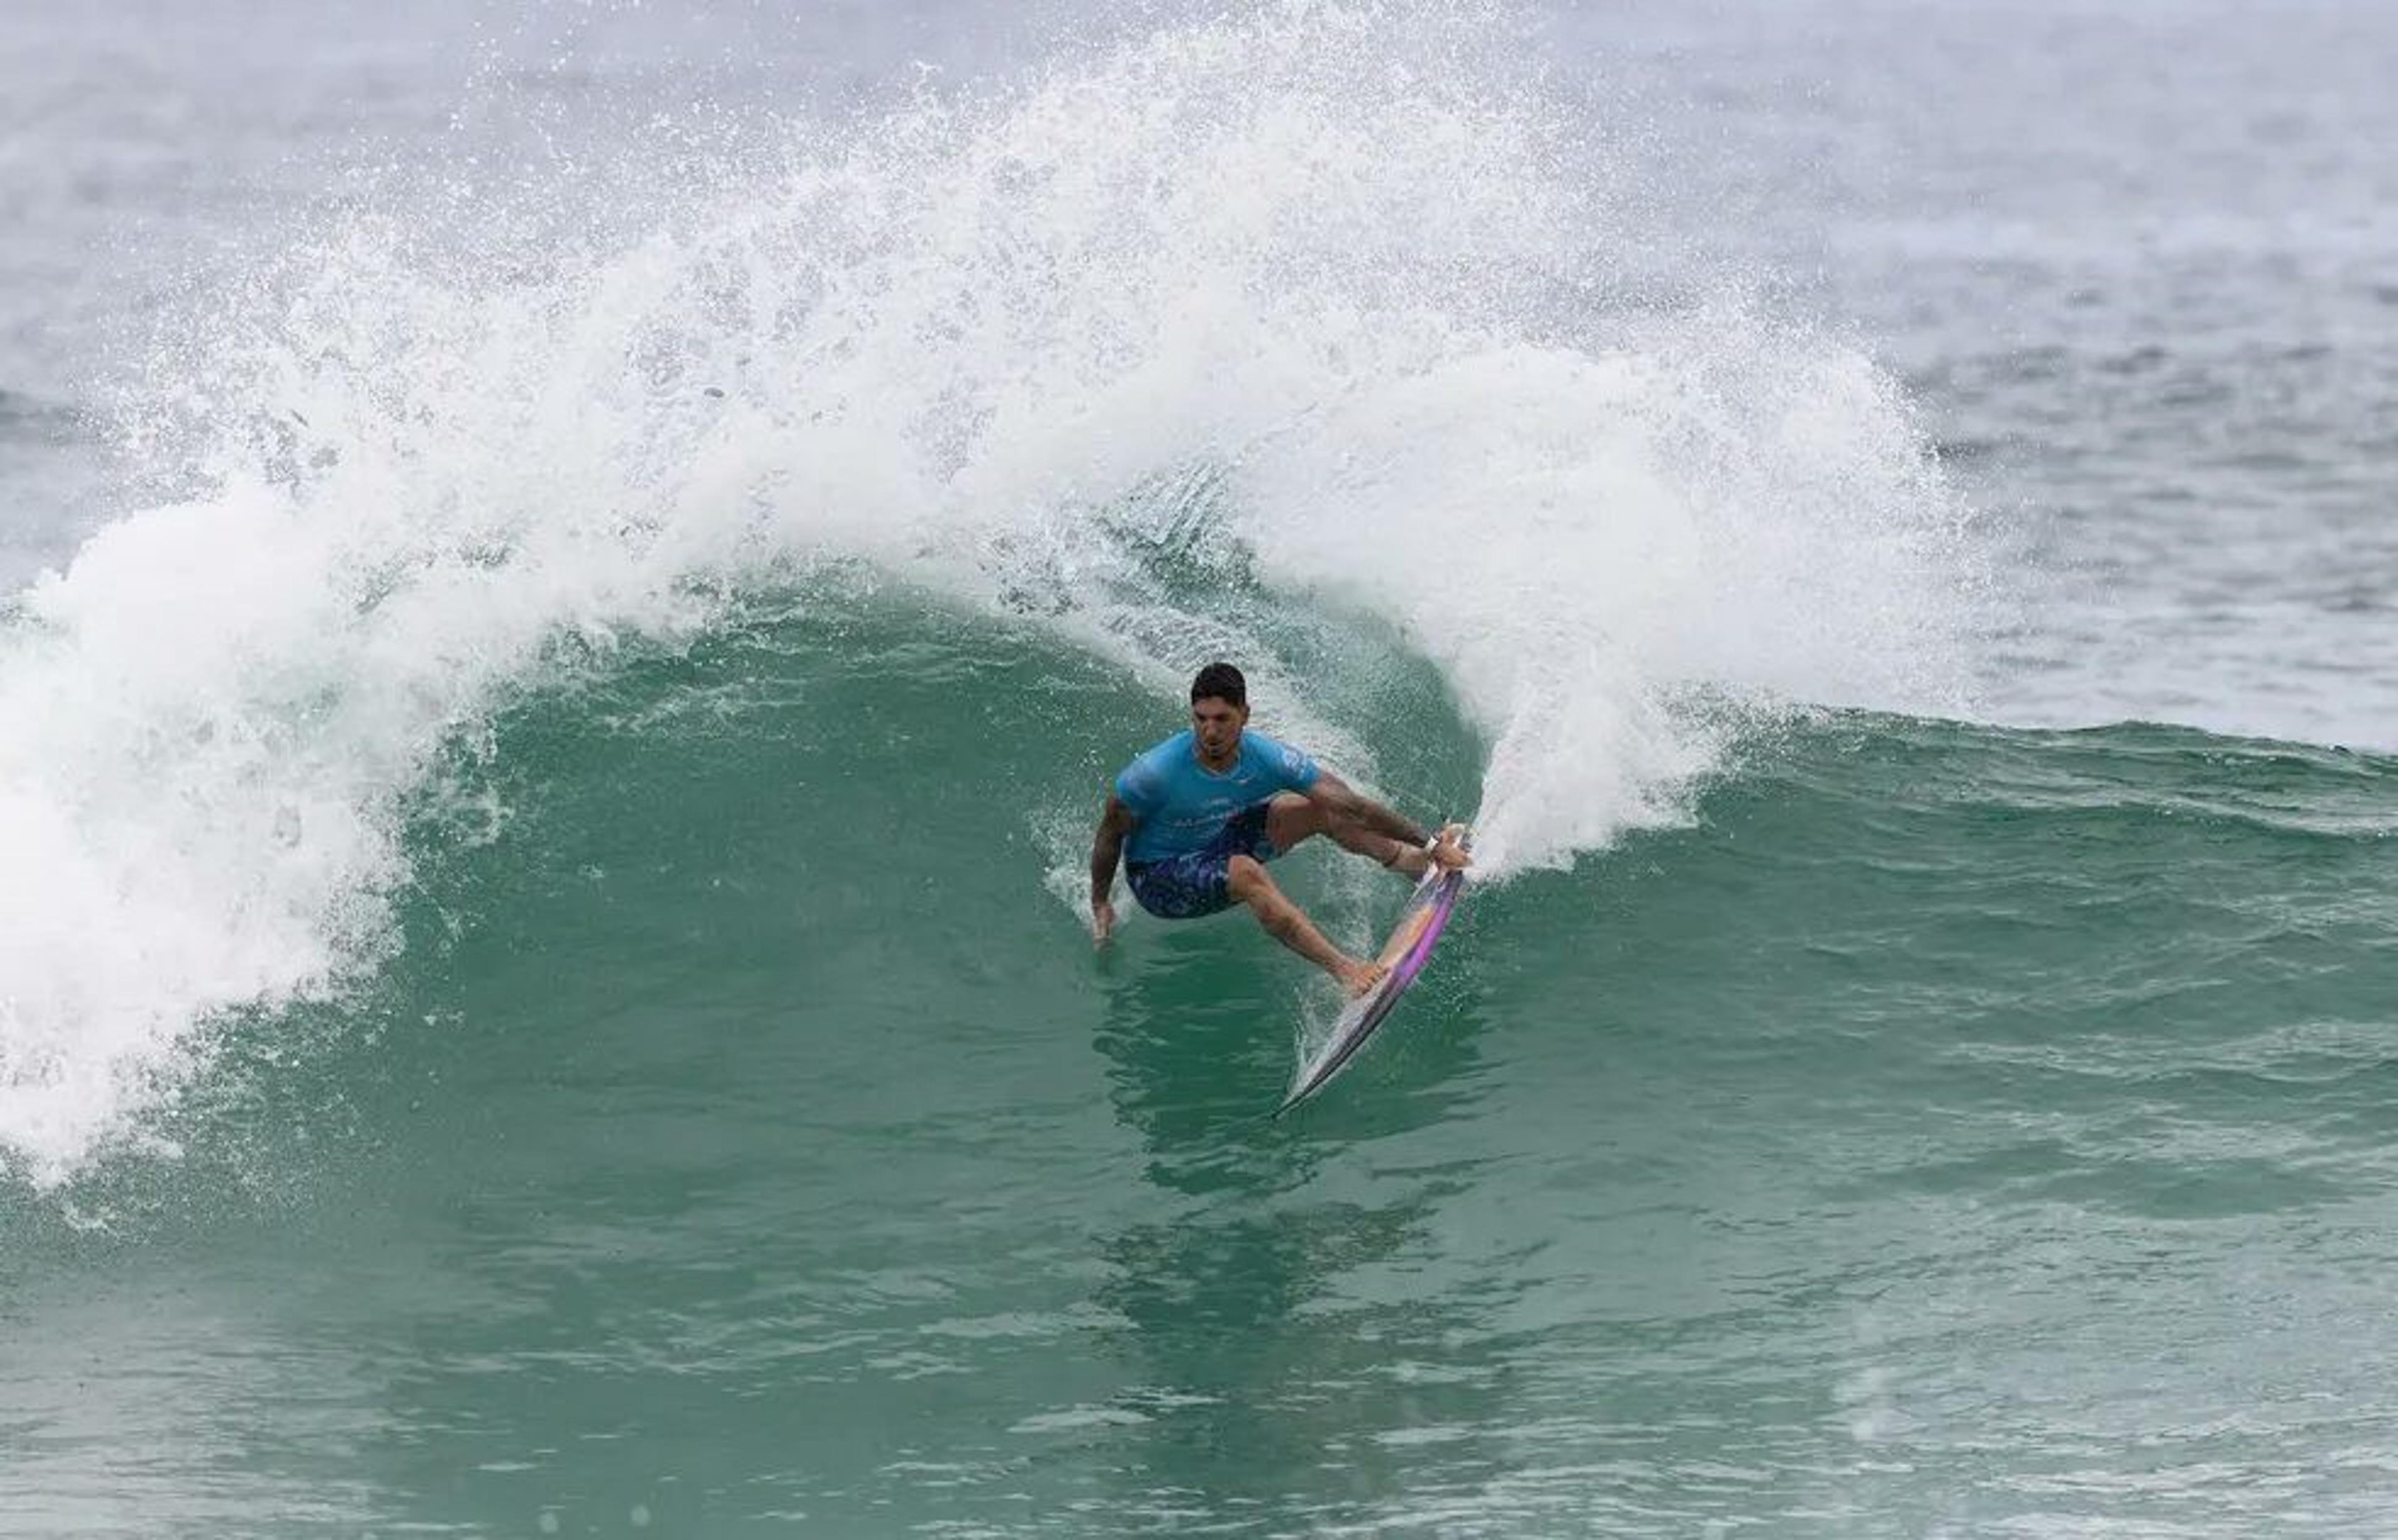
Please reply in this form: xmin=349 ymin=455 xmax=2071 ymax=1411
xmin=1091 ymin=662 xmax=1470 ymax=995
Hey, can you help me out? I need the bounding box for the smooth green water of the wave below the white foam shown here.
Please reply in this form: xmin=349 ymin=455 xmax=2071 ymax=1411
xmin=0 ymin=593 xmax=2398 ymax=1538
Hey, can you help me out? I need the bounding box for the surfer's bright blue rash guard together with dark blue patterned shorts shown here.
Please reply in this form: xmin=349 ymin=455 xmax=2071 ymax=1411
xmin=1115 ymin=729 xmax=1319 ymax=919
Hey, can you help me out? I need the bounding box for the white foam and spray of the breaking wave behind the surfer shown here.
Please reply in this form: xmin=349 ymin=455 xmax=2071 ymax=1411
xmin=0 ymin=5 xmax=1988 ymax=1183
